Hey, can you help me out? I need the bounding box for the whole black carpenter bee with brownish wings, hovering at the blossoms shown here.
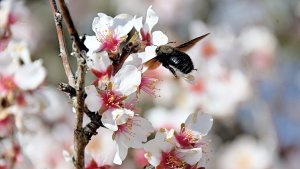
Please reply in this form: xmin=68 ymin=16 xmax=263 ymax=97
xmin=146 ymin=33 xmax=209 ymax=80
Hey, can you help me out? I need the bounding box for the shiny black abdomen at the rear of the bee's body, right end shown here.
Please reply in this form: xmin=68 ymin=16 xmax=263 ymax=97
xmin=169 ymin=54 xmax=194 ymax=74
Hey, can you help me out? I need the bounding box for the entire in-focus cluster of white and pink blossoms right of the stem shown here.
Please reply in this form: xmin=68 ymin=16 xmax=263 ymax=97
xmin=85 ymin=6 xmax=212 ymax=168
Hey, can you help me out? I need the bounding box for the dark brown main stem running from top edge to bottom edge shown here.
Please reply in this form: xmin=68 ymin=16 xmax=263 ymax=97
xmin=58 ymin=0 xmax=89 ymax=169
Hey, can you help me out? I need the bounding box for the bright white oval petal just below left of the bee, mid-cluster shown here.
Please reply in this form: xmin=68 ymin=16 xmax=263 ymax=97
xmin=112 ymin=65 xmax=141 ymax=96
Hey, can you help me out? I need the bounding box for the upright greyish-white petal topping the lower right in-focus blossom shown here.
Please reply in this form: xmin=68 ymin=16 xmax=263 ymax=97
xmin=185 ymin=112 xmax=213 ymax=136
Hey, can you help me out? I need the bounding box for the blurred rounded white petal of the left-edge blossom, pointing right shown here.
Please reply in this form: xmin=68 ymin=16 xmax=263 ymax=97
xmin=15 ymin=60 xmax=46 ymax=90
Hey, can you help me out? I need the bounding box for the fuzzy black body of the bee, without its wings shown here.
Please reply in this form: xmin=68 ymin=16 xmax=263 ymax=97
xmin=156 ymin=45 xmax=194 ymax=77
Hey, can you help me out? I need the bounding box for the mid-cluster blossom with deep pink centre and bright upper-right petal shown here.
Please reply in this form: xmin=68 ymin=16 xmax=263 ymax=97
xmin=85 ymin=65 xmax=141 ymax=114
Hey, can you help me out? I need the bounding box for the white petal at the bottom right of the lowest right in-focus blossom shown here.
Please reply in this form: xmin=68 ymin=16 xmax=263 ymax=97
xmin=176 ymin=147 xmax=202 ymax=165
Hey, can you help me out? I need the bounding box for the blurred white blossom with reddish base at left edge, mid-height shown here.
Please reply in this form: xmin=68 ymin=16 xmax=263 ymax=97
xmin=0 ymin=41 xmax=46 ymax=110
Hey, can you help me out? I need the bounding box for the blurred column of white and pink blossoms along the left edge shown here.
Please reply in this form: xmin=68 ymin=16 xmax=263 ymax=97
xmin=0 ymin=0 xmax=69 ymax=169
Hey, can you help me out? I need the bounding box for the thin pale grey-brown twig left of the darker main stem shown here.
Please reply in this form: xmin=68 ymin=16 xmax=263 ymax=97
xmin=49 ymin=0 xmax=75 ymax=86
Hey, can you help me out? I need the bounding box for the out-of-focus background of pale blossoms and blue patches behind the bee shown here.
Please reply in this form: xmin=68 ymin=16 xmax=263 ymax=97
xmin=4 ymin=0 xmax=300 ymax=169
